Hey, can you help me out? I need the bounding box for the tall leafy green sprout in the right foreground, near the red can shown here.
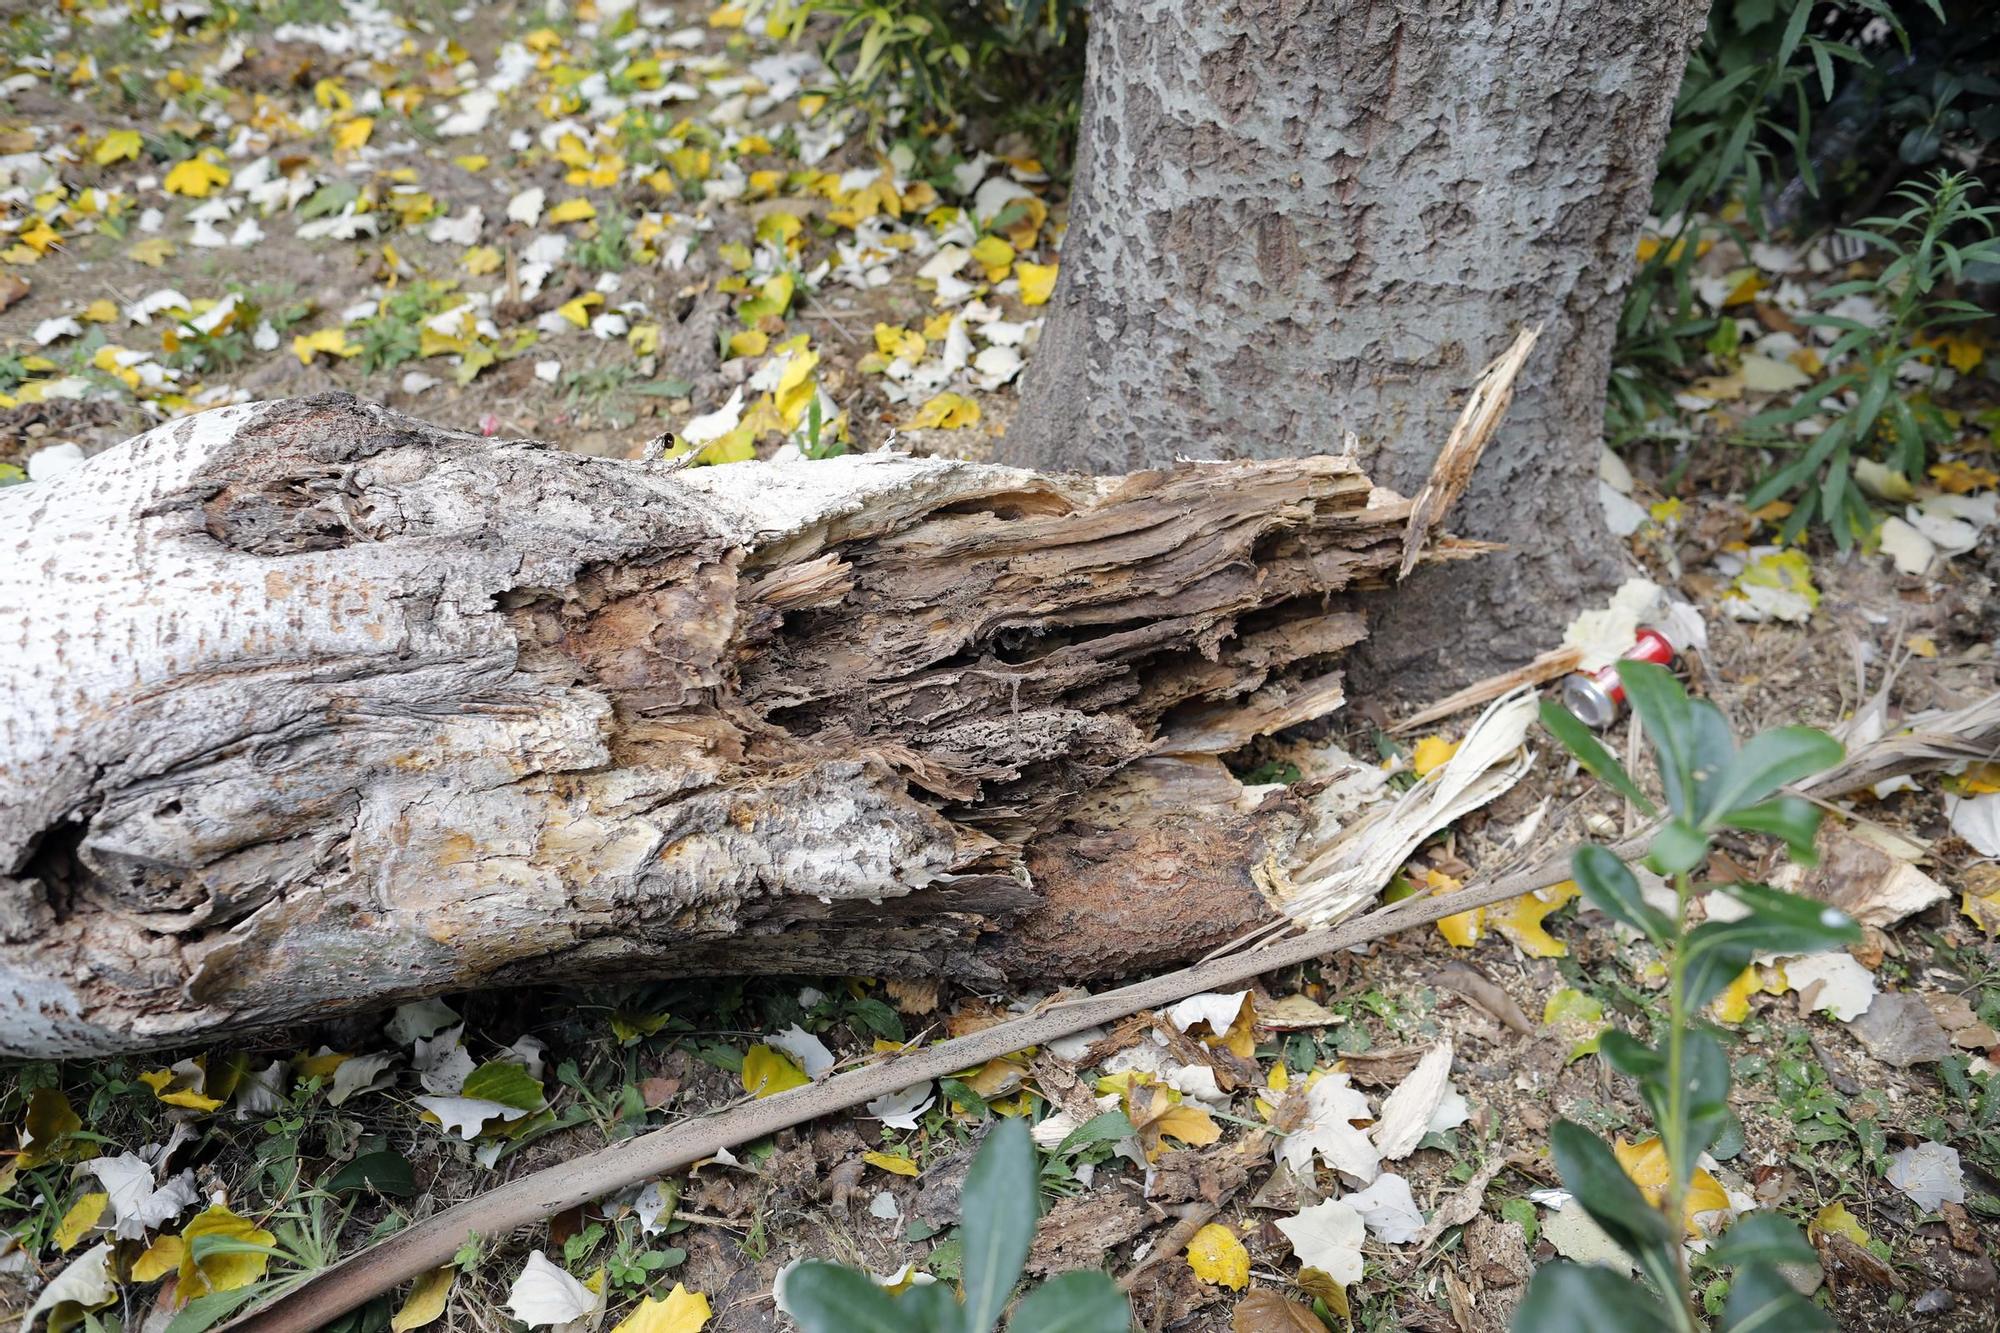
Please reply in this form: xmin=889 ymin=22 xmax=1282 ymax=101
xmin=1514 ymin=662 xmax=1860 ymax=1333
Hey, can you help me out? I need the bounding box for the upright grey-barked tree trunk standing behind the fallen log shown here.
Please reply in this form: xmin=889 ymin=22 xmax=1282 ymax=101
xmin=1002 ymin=0 xmax=1708 ymax=691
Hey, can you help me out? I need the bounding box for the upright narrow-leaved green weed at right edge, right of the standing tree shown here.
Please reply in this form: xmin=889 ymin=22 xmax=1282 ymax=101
xmin=1738 ymin=172 xmax=2000 ymax=550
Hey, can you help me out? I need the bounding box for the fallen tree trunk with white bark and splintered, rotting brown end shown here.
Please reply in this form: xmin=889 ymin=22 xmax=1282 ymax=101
xmin=0 ymin=396 xmax=1448 ymax=1055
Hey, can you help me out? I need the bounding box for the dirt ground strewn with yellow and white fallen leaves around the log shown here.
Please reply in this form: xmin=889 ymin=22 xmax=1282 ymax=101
xmin=0 ymin=0 xmax=2000 ymax=1333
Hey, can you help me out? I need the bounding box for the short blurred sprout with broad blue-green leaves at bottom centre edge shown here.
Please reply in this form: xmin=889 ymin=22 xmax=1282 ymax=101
xmin=784 ymin=1119 xmax=1132 ymax=1333
